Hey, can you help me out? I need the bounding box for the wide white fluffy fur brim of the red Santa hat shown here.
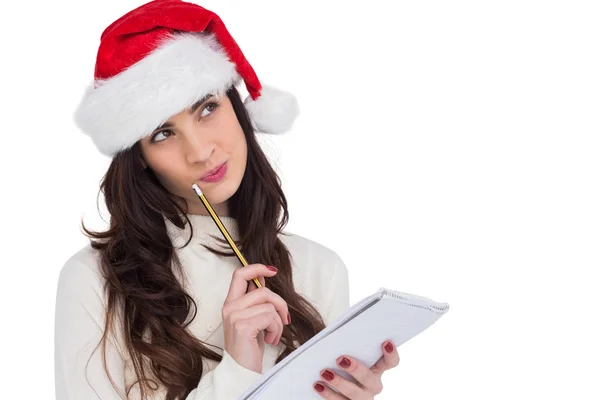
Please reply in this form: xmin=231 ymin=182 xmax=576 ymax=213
xmin=74 ymin=33 xmax=241 ymax=156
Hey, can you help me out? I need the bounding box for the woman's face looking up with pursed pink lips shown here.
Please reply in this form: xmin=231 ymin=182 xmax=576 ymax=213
xmin=140 ymin=94 xmax=247 ymax=216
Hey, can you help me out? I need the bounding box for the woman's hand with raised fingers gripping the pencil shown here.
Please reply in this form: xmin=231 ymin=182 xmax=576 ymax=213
xmin=222 ymin=264 xmax=290 ymax=373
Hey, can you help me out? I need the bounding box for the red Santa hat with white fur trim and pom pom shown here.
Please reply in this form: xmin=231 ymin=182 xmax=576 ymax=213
xmin=75 ymin=0 xmax=298 ymax=156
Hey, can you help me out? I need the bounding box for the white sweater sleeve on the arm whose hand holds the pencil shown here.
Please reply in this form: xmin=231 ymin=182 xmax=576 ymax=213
xmin=54 ymin=255 xmax=262 ymax=400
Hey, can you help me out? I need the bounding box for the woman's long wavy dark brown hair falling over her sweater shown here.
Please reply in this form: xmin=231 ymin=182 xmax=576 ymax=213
xmin=82 ymin=87 xmax=325 ymax=400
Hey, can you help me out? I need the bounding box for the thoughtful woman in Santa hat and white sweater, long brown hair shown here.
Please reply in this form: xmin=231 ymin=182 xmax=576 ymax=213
xmin=56 ymin=0 xmax=398 ymax=400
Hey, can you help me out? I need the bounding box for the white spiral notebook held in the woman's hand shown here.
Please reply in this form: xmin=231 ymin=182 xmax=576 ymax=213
xmin=238 ymin=288 xmax=449 ymax=400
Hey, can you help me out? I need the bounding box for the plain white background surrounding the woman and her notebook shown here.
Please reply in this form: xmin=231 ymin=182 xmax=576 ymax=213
xmin=0 ymin=0 xmax=600 ymax=400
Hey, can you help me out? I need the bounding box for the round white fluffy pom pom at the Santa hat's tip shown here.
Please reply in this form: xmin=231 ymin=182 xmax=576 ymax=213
xmin=244 ymin=85 xmax=299 ymax=134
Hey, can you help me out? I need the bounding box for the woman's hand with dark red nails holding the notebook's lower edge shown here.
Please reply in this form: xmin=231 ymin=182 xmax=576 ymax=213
xmin=313 ymin=341 xmax=400 ymax=400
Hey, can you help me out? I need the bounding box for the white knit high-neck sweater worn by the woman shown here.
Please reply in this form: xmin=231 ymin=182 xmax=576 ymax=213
xmin=55 ymin=215 xmax=349 ymax=400
